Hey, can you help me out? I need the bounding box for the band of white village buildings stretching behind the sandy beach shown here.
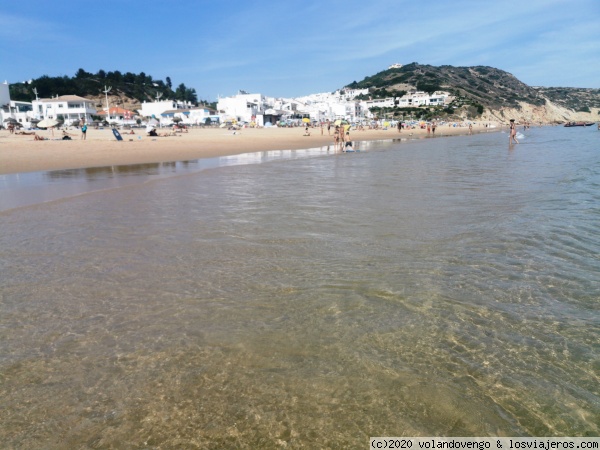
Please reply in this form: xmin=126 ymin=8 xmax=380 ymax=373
xmin=0 ymin=83 xmax=453 ymax=128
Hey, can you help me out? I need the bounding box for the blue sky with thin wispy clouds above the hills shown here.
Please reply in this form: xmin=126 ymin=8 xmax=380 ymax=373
xmin=0 ymin=0 xmax=600 ymax=100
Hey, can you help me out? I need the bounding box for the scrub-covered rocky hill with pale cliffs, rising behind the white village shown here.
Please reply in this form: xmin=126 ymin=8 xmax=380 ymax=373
xmin=346 ymin=63 xmax=600 ymax=123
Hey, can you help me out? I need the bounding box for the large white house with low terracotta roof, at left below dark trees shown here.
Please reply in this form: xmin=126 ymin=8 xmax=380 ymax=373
xmin=31 ymin=95 xmax=96 ymax=125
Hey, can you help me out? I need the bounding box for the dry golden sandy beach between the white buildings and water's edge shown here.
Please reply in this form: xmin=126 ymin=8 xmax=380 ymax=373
xmin=0 ymin=124 xmax=501 ymax=174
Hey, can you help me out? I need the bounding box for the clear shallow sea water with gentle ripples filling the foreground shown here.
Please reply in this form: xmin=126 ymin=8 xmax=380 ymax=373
xmin=0 ymin=127 xmax=600 ymax=449
